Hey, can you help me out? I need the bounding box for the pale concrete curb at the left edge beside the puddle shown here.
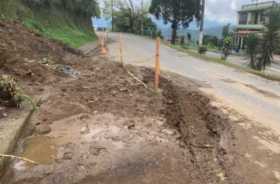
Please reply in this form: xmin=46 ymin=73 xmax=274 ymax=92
xmin=0 ymin=110 xmax=34 ymax=177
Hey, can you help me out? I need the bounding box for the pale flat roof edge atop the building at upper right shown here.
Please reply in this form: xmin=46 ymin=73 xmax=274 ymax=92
xmin=239 ymin=1 xmax=278 ymax=12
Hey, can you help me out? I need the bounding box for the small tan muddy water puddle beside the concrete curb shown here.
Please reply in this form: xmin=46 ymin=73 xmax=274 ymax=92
xmin=22 ymin=136 xmax=57 ymax=166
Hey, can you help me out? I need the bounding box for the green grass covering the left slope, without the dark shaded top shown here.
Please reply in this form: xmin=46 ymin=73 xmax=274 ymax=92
xmin=0 ymin=0 xmax=96 ymax=48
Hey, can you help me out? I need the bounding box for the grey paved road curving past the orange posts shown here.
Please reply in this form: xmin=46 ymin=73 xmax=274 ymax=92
xmin=106 ymin=34 xmax=280 ymax=132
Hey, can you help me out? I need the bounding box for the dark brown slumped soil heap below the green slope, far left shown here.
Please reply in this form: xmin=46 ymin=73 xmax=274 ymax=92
xmin=0 ymin=21 xmax=80 ymax=86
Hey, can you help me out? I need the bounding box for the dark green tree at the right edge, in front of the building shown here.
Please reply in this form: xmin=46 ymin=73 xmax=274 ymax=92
xmin=257 ymin=7 xmax=280 ymax=70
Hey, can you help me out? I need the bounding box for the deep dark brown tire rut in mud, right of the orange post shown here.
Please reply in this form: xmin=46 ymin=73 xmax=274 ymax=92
xmin=144 ymin=70 xmax=242 ymax=183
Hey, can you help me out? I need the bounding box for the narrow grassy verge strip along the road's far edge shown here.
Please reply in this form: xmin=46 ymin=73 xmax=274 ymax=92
xmin=169 ymin=45 xmax=280 ymax=81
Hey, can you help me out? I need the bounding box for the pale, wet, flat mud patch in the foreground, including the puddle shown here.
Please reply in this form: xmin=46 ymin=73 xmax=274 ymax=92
xmin=1 ymin=114 xmax=191 ymax=184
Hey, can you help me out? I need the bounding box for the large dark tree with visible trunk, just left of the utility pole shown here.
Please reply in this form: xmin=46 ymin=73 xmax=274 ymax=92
xmin=150 ymin=0 xmax=201 ymax=44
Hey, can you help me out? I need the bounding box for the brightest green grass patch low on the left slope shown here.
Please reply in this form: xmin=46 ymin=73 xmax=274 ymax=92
xmin=24 ymin=19 xmax=96 ymax=48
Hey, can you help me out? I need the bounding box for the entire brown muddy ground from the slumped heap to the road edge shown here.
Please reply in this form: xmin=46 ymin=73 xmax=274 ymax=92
xmin=0 ymin=22 xmax=277 ymax=184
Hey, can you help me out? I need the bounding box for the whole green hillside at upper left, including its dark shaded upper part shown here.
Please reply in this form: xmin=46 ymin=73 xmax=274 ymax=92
xmin=0 ymin=0 xmax=99 ymax=47
